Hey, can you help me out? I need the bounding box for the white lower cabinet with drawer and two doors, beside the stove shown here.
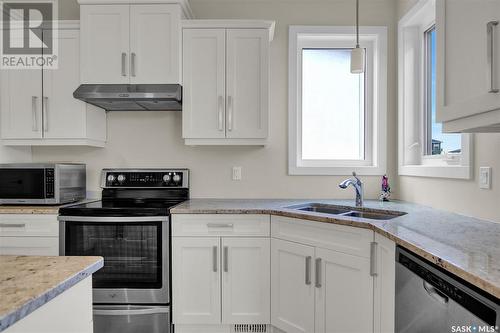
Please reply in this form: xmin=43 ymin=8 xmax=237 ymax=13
xmin=172 ymin=214 xmax=271 ymax=324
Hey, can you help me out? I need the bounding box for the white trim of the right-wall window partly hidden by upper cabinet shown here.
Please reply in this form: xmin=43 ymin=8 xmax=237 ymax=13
xmin=398 ymin=0 xmax=473 ymax=179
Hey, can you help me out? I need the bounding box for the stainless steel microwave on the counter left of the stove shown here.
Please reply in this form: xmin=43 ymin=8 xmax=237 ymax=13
xmin=0 ymin=163 xmax=87 ymax=205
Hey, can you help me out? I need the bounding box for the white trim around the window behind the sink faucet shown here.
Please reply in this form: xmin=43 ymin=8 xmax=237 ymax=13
xmin=288 ymin=26 xmax=387 ymax=175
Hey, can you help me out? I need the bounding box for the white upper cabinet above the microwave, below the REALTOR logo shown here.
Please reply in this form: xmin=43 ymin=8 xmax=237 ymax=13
xmin=0 ymin=22 xmax=106 ymax=147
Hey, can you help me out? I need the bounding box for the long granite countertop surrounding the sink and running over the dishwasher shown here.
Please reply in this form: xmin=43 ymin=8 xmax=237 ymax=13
xmin=171 ymin=199 xmax=500 ymax=298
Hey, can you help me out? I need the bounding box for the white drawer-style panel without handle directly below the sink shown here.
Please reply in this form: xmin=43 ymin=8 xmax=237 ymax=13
xmin=271 ymin=216 xmax=373 ymax=257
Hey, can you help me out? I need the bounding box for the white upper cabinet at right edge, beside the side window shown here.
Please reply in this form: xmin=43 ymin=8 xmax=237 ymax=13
xmin=436 ymin=0 xmax=500 ymax=132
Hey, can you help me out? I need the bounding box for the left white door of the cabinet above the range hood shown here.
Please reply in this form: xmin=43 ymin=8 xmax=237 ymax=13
xmin=80 ymin=5 xmax=130 ymax=83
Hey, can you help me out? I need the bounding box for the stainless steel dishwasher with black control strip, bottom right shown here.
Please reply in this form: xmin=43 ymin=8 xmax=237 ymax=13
xmin=396 ymin=247 xmax=500 ymax=333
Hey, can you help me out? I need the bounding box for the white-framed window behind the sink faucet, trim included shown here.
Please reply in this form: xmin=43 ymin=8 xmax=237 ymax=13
xmin=289 ymin=26 xmax=387 ymax=175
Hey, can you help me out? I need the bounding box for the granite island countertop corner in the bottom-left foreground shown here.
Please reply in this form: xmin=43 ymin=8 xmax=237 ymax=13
xmin=0 ymin=256 xmax=104 ymax=332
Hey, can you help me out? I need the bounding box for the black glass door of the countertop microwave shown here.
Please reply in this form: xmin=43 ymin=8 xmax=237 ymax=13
xmin=0 ymin=169 xmax=45 ymax=199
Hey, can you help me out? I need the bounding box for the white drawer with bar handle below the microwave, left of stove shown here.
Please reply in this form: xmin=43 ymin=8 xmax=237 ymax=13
xmin=0 ymin=214 xmax=59 ymax=237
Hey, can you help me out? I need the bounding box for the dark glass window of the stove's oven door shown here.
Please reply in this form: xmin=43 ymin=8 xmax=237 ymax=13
xmin=64 ymin=221 xmax=166 ymax=289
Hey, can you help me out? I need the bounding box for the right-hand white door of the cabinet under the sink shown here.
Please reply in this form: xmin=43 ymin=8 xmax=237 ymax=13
xmin=314 ymin=248 xmax=373 ymax=333
